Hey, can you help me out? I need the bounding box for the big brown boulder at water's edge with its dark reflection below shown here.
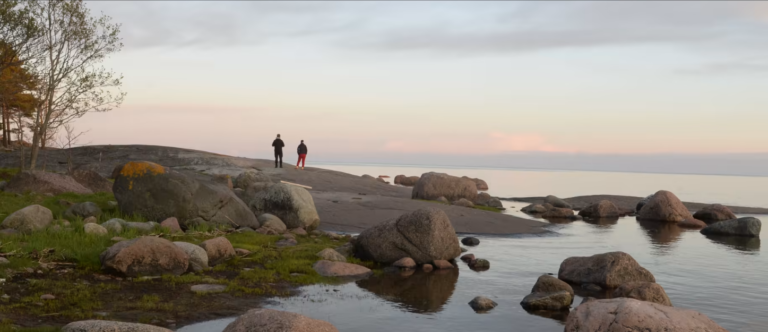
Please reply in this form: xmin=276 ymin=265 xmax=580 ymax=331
xmin=355 ymin=208 xmax=461 ymax=264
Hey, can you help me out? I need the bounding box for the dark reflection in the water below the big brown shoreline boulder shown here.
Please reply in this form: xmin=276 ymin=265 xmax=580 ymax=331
xmin=357 ymin=269 xmax=459 ymax=313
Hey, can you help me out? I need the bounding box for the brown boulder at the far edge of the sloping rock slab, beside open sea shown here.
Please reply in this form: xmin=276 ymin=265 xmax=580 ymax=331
xmin=411 ymin=172 xmax=477 ymax=202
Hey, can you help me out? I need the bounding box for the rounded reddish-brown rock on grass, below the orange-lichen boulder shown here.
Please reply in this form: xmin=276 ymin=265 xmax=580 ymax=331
xmin=99 ymin=236 xmax=189 ymax=277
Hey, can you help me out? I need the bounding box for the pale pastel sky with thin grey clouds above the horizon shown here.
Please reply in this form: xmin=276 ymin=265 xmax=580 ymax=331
xmin=75 ymin=1 xmax=768 ymax=175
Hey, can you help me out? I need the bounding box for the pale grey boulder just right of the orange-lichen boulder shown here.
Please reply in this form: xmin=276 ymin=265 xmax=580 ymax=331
xmin=251 ymin=183 xmax=320 ymax=230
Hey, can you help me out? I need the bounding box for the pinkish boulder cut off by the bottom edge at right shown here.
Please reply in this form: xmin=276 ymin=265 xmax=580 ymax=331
xmin=565 ymin=298 xmax=727 ymax=332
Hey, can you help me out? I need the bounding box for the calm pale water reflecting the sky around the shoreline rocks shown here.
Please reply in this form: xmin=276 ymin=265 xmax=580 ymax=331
xmin=179 ymin=166 xmax=768 ymax=332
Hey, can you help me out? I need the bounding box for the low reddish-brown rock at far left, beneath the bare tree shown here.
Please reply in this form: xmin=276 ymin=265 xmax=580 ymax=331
xmin=5 ymin=171 xmax=93 ymax=195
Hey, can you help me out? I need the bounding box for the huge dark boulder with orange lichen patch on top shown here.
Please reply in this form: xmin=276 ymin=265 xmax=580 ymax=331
xmin=114 ymin=161 xmax=258 ymax=228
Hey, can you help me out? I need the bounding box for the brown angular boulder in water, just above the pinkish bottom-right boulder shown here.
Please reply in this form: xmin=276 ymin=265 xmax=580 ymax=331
xmin=557 ymin=251 xmax=656 ymax=288
